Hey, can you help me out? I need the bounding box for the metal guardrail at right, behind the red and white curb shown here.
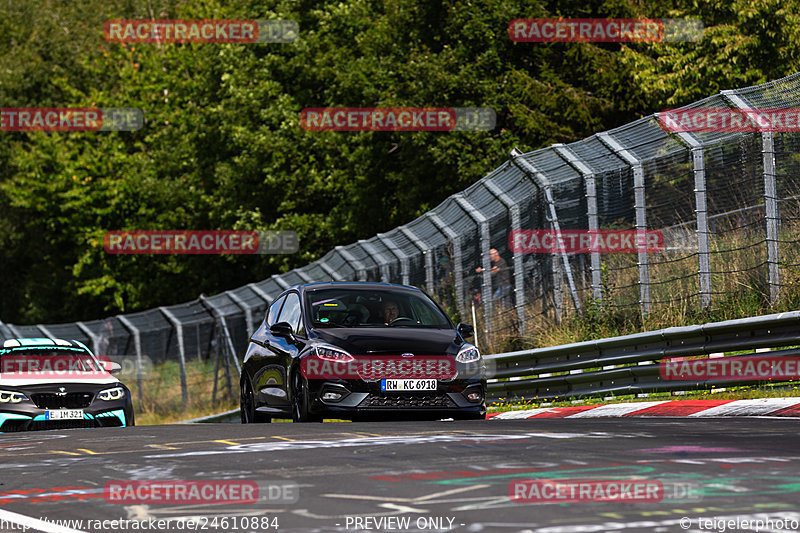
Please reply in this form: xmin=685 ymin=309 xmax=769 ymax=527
xmin=484 ymin=311 xmax=800 ymax=399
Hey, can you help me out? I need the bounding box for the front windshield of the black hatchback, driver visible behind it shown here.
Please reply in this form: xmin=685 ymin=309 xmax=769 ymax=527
xmin=306 ymin=288 xmax=453 ymax=329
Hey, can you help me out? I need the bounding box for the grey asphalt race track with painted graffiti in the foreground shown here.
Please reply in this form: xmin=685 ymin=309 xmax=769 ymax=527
xmin=0 ymin=418 xmax=800 ymax=533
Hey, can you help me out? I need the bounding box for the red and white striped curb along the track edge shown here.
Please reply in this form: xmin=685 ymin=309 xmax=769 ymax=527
xmin=486 ymin=397 xmax=800 ymax=420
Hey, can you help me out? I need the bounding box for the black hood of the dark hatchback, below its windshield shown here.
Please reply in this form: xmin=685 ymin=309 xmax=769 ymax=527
xmin=313 ymin=327 xmax=461 ymax=355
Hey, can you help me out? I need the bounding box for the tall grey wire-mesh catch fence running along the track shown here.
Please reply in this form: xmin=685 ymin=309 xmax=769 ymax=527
xmin=0 ymin=73 xmax=800 ymax=412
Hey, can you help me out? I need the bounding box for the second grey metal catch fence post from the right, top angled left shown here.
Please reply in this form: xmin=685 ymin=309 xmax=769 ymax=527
xmin=676 ymin=132 xmax=711 ymax=308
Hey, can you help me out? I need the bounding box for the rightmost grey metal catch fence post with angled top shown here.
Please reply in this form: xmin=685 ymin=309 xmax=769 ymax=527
xmin=722 ymin=91 xmax=781 ymax=303
